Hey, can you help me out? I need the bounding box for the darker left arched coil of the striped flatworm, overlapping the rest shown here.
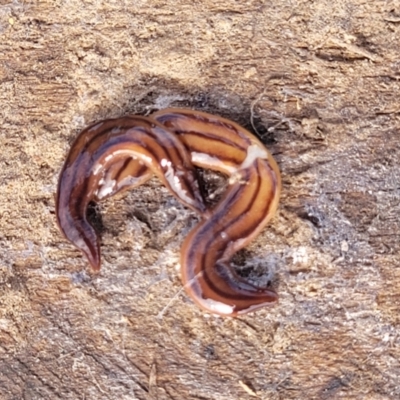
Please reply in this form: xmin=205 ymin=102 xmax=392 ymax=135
xmin=56 ymin=116 xmax=206 ymax=271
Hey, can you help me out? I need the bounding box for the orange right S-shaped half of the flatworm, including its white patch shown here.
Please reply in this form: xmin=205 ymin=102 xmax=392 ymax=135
xmin=152 ymin=109 xmax=281 ymax=316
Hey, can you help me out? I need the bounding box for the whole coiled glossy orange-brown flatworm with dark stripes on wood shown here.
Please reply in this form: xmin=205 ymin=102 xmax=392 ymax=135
xmin=57 ymin=109 xmax=281 ymax=316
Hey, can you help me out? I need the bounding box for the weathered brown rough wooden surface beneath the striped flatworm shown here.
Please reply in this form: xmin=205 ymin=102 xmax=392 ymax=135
xmin=0 ymin=0 xmax=400 ymax=400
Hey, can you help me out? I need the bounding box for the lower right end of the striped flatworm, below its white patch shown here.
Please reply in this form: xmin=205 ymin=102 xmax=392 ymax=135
xmin=181 ymin=159 xmax=279 ymax=316
